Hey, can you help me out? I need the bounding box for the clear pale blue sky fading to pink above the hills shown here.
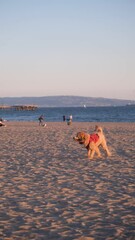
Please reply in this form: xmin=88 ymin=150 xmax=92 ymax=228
xmin=0 ymin=0 xmax=135 ymax=100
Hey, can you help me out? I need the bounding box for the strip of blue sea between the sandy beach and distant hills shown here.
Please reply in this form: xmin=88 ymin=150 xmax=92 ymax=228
xmin=0 ymin=105 xmax=135 ymax=122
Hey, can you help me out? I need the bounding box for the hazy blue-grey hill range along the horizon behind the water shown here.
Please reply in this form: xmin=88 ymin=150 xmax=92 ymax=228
xmin=0 ymin=96 xmax=135 ymax=107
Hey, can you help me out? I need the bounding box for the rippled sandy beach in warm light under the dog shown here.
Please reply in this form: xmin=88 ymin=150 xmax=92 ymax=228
xmin=0 ymin=122 xmax=135 ymax=240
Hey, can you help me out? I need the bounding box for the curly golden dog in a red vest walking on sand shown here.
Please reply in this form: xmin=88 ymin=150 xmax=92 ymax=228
xmin=73 ymin=126 xmax=111 ymax=159
